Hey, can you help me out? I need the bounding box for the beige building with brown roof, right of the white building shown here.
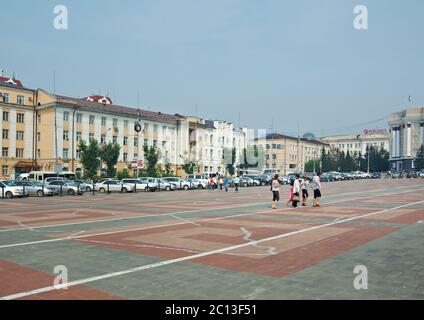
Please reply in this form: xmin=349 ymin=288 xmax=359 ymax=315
xmin=250 ymin=133 xmax=330 ymax=175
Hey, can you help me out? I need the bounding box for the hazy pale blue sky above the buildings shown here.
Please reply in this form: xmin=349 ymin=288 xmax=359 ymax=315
xmin=0 ymin=0 xmax=424 ymax=136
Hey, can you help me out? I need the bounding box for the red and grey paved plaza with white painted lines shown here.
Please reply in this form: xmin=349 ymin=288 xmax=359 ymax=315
xmin=0 ymin=179 xmax=424 ymax=300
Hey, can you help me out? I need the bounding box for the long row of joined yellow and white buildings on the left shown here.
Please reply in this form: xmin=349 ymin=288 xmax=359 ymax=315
xmin=0 ymin=78 xmax=246 ymax=179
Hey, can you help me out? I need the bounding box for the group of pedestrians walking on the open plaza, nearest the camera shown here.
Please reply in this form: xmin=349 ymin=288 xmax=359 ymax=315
xmin=271 ymin=173 xmax=322 ymax=209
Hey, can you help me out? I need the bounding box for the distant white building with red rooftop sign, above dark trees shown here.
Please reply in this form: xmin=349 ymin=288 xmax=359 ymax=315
xmin=320 ymin=129 xmax=390 ymax=155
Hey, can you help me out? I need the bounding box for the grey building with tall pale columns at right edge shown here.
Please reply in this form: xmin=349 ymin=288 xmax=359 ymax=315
xmin=388 ymin=107 xmax=424 ymax=171
